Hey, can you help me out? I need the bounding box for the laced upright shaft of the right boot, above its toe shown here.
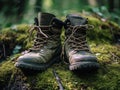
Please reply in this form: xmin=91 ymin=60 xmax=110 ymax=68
xmin=65 ymin=14 xmax=89 ymax=51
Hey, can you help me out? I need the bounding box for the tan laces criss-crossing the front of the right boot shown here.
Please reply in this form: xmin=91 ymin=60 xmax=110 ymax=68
xmin=65 ymin=24 xmax=94 ymax=51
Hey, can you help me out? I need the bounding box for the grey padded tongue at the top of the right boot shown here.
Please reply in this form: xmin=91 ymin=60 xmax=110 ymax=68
xmin=67 ymin=14 xmax=87 ymax=26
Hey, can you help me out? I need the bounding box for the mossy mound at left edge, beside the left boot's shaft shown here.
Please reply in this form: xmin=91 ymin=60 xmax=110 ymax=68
xmin=0 ymin=24 xmax=31 ymax=59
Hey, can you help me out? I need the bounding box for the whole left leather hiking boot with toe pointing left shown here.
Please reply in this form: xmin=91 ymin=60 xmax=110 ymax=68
xmin=15 ymin=13 xmax=63 ymax=70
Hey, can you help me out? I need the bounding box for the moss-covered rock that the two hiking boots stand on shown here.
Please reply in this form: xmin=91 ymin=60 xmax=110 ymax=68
xmin=0 ymin=16 xmax=120 ymax=90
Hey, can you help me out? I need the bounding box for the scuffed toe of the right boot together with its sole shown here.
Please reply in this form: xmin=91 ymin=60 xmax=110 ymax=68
xmin=69 ymin=55 xmax=99 ymax=70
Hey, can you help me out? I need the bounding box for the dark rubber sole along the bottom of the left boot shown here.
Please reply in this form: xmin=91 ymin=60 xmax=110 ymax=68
xmin=15 ymin=57 xmax=60 ymax=70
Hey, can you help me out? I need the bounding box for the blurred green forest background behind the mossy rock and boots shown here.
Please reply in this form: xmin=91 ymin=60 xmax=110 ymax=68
xmin=0 ymin=0 xmax=120 ymax=28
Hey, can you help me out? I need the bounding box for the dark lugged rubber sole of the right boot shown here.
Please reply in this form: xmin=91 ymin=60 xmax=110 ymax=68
xmin=69 ymin=61 xmax=100 ymax=71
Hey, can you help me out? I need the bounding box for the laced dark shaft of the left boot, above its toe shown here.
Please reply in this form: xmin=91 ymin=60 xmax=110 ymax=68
xmin=31 ymin=13 xmax=63 ymax=48
